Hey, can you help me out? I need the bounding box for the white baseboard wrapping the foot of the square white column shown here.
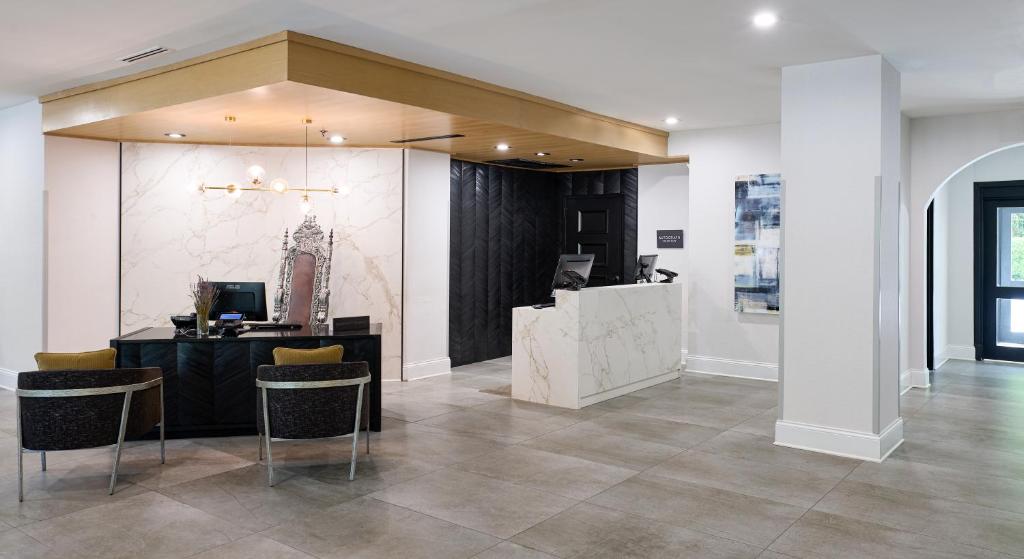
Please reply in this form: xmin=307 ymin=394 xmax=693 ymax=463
xmin=775 ymin=418 xmax=903 ymax=462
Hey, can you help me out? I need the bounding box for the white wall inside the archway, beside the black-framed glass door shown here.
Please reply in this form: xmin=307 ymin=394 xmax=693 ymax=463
xmin=933 ymin=146 xmax=1024 ymax=366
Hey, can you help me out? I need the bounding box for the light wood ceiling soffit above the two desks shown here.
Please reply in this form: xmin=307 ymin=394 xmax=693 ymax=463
xmin=40 ymin=31 xmax=688 ymax=171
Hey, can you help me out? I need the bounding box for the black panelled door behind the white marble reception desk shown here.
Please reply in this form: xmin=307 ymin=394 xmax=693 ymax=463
xmin=562 ymin=195 xmax=625 ymax=287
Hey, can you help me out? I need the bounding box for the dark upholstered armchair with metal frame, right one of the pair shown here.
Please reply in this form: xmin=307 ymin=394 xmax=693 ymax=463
xmin=256 ymin=361 xmax=370 ymax=487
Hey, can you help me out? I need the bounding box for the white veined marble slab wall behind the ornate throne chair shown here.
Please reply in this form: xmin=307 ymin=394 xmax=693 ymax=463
xmin=121 ymin=143 xmax=402 ymax=379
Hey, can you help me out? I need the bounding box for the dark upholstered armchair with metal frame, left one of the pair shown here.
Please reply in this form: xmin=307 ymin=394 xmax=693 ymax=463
xmin=16 ymin=367 xmax=164 ymax=501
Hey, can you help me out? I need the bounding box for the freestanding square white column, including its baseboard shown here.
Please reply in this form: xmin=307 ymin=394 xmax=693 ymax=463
xmin=775 ymin=55 xmax=903 ymax=461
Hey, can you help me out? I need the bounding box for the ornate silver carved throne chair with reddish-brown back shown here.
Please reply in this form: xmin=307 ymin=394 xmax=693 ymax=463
xmin=273 ymin=215 xmax=334 ymax=325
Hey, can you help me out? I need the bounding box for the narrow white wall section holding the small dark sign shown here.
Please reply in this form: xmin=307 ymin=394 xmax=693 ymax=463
xmin=637 ymin=165 xmax=690 ymax=353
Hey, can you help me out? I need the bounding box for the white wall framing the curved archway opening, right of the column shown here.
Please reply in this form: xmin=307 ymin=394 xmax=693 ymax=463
xmin=906 ymin=111 xmax=1024 ymax=386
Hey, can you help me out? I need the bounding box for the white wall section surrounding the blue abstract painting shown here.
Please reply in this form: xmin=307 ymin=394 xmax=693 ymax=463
xmin=669 ymin=124 xmax=785 ymax=380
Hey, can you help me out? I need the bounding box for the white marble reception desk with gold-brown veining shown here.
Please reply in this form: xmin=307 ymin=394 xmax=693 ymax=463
xmin=512 ymin=284 xmax=683 ymax=410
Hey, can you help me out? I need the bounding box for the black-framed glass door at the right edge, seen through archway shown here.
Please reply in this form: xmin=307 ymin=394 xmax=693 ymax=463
xmin=974 ymin=181 xmax=1024 ymax=361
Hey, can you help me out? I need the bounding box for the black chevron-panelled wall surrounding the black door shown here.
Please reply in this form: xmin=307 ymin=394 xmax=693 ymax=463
xmin=449 ymin=159 xmax=637 ymax=367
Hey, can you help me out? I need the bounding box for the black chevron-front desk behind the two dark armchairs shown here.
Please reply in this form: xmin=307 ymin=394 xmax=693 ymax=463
xmin=111 ymin=324 xmax=381 ymax=438
